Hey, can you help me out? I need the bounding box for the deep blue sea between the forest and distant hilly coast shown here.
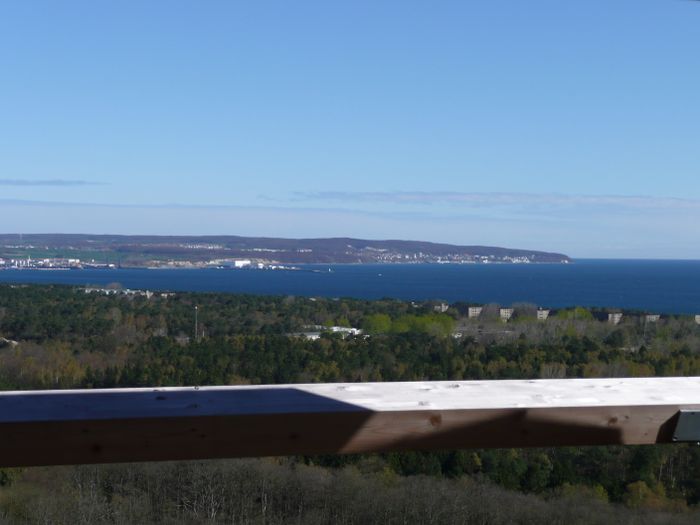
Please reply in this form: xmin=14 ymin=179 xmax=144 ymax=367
xmin=0 ymin=259 xmax=700 ymax=314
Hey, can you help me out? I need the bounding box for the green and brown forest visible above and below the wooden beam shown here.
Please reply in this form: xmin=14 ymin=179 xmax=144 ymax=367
xmin=0 ymin=285 xmax=700 ymax=523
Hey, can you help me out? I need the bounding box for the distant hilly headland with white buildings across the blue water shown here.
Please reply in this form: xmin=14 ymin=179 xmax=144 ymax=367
xmin=0 ymin=234 xmax=571 ymax=265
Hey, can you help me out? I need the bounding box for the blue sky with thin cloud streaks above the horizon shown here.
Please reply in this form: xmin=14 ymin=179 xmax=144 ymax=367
xmin=0 ymin=0 xmax=700 ymax=258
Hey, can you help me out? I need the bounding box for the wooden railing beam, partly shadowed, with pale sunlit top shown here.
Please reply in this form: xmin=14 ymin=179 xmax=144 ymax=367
xmin=0 ymin=377 xmax=700 ymax=466
